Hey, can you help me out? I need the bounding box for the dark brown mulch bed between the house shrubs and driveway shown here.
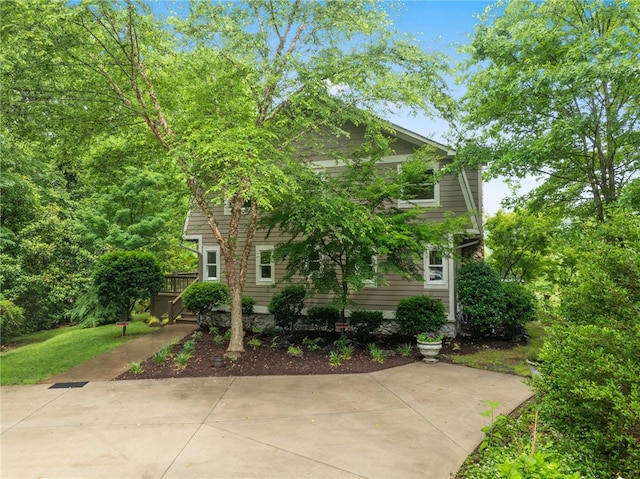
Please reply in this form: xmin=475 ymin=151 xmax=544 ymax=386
xmin=116 ymin=331 xmax=517 ymax=380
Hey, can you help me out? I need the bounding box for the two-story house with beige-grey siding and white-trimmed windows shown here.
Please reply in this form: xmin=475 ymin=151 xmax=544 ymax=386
xmin=175 ymin=121 xmax=482 ymax=335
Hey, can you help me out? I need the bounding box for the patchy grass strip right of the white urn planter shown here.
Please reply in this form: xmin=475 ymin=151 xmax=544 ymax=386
xmin=444 ymin=322 xmax=545 ymax=377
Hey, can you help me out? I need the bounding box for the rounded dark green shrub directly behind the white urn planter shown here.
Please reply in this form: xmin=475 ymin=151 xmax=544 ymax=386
xmin=396 ymin=295 xmax=447 ymax=336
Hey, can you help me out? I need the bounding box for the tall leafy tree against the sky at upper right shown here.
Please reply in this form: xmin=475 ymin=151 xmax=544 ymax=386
xmin=459 ymin=0 xmax=640 ymax=222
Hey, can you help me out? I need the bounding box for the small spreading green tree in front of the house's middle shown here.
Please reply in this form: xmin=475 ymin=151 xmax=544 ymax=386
xmin=262 ymin=152 xmax=467 ymax=320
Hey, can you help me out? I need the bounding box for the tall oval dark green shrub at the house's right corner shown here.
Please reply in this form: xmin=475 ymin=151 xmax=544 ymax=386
xmin=456 ymin=263 xmax=504 ymax=335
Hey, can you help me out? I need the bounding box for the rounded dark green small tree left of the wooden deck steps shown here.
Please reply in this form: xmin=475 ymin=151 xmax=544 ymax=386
xmin=93 ymin=251 xmax=164 ymax=321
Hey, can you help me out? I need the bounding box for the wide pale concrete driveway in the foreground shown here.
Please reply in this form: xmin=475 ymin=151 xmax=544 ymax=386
xmin=0 ymin=363 xmax=532 ymax=479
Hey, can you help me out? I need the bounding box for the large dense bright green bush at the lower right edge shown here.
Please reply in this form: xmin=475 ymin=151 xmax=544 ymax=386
xmin=535 ymin=318 xmax=640 ymax=477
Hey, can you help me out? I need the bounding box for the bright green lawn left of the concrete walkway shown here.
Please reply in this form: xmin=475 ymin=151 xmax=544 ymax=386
xmin=0 ymin=321 xmax=154 ymax=385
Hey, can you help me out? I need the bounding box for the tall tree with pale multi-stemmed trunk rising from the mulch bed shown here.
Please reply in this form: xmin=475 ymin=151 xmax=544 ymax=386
xmin=16 ymin=0 xmax=451 ymax=354
